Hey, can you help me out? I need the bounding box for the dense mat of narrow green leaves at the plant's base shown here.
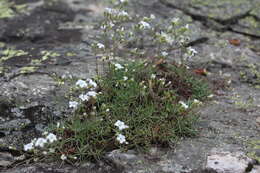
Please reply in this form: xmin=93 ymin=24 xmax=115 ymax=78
xmin=48 ymin=61 xmax=209 ymax=160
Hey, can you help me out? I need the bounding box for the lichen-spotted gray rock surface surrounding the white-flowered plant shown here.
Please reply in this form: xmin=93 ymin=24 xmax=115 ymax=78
xmin=0 ymin=0 xmax=260 ymax=173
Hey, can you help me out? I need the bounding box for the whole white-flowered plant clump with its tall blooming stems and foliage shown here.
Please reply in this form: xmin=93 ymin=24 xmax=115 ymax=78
xmin=24 ymin=0 xmax=210 ymax=163
